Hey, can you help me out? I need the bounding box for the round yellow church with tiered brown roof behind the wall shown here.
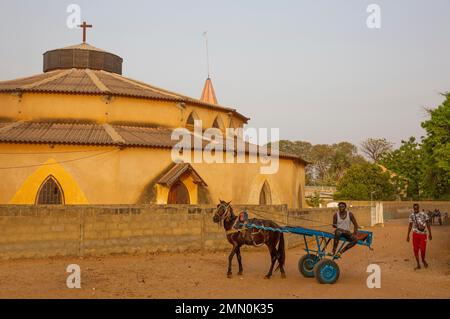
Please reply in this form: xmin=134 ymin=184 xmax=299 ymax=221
xmin=0 ymin=23 xmax=307 ymax=208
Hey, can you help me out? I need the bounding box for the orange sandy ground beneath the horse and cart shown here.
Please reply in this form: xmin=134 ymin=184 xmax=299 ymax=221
xmin=0 ymin=220 xmax=450 ymax=298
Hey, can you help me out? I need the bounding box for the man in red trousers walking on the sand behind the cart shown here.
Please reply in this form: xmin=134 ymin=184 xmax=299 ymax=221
xmin=406 ymin=203 xmax=433 ymax=270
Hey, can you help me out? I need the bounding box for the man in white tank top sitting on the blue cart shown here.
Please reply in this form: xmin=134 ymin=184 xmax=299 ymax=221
xmin=332 ymin=202 xmax=358 ymax=256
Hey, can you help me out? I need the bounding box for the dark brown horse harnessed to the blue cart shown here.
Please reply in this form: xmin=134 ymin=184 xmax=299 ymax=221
xmin=213 ymin=200 xmax=286 ymax=279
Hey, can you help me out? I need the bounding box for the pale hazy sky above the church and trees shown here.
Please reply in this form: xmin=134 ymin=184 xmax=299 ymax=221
xmin=0 ymin=0 xmax=450 ymax=144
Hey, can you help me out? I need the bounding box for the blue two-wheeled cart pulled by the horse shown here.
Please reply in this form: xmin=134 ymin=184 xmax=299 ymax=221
xmin=245 ymin=223 xmax=373 ymax=284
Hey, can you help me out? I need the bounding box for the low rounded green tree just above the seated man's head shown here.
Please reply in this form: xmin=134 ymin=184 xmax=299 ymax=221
xmin=334 ymin=163 xmax=395 ymax=200
